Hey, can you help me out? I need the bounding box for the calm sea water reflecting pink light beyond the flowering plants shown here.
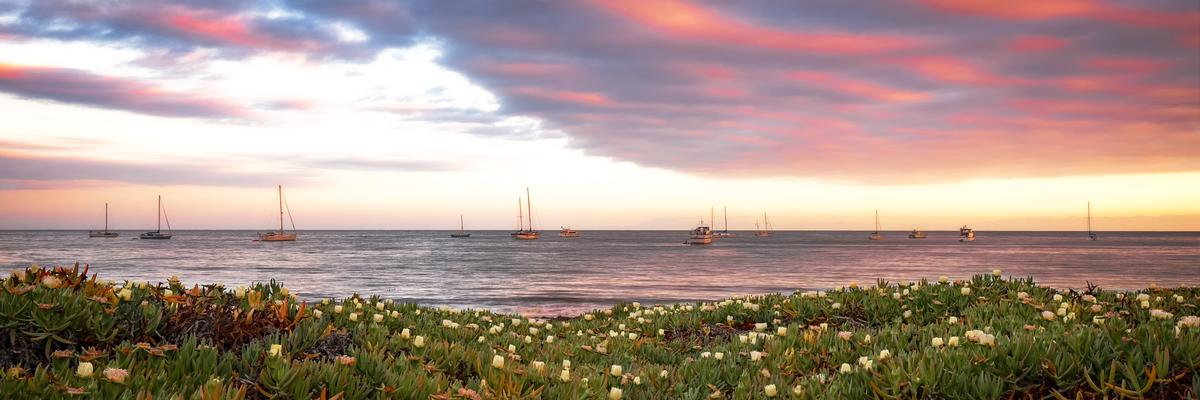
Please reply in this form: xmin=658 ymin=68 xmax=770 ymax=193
xmin=0 ymin=231 xmax=1200 ymax=315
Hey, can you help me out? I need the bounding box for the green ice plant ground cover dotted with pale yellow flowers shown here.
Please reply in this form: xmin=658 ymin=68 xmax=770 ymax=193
xmin=0 ymin=265 xmax=1200 ymax=399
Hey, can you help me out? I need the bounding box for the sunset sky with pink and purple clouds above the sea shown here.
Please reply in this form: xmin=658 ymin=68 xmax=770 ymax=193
xmin=0 ymin=0 xmax=1200 ymax=231
